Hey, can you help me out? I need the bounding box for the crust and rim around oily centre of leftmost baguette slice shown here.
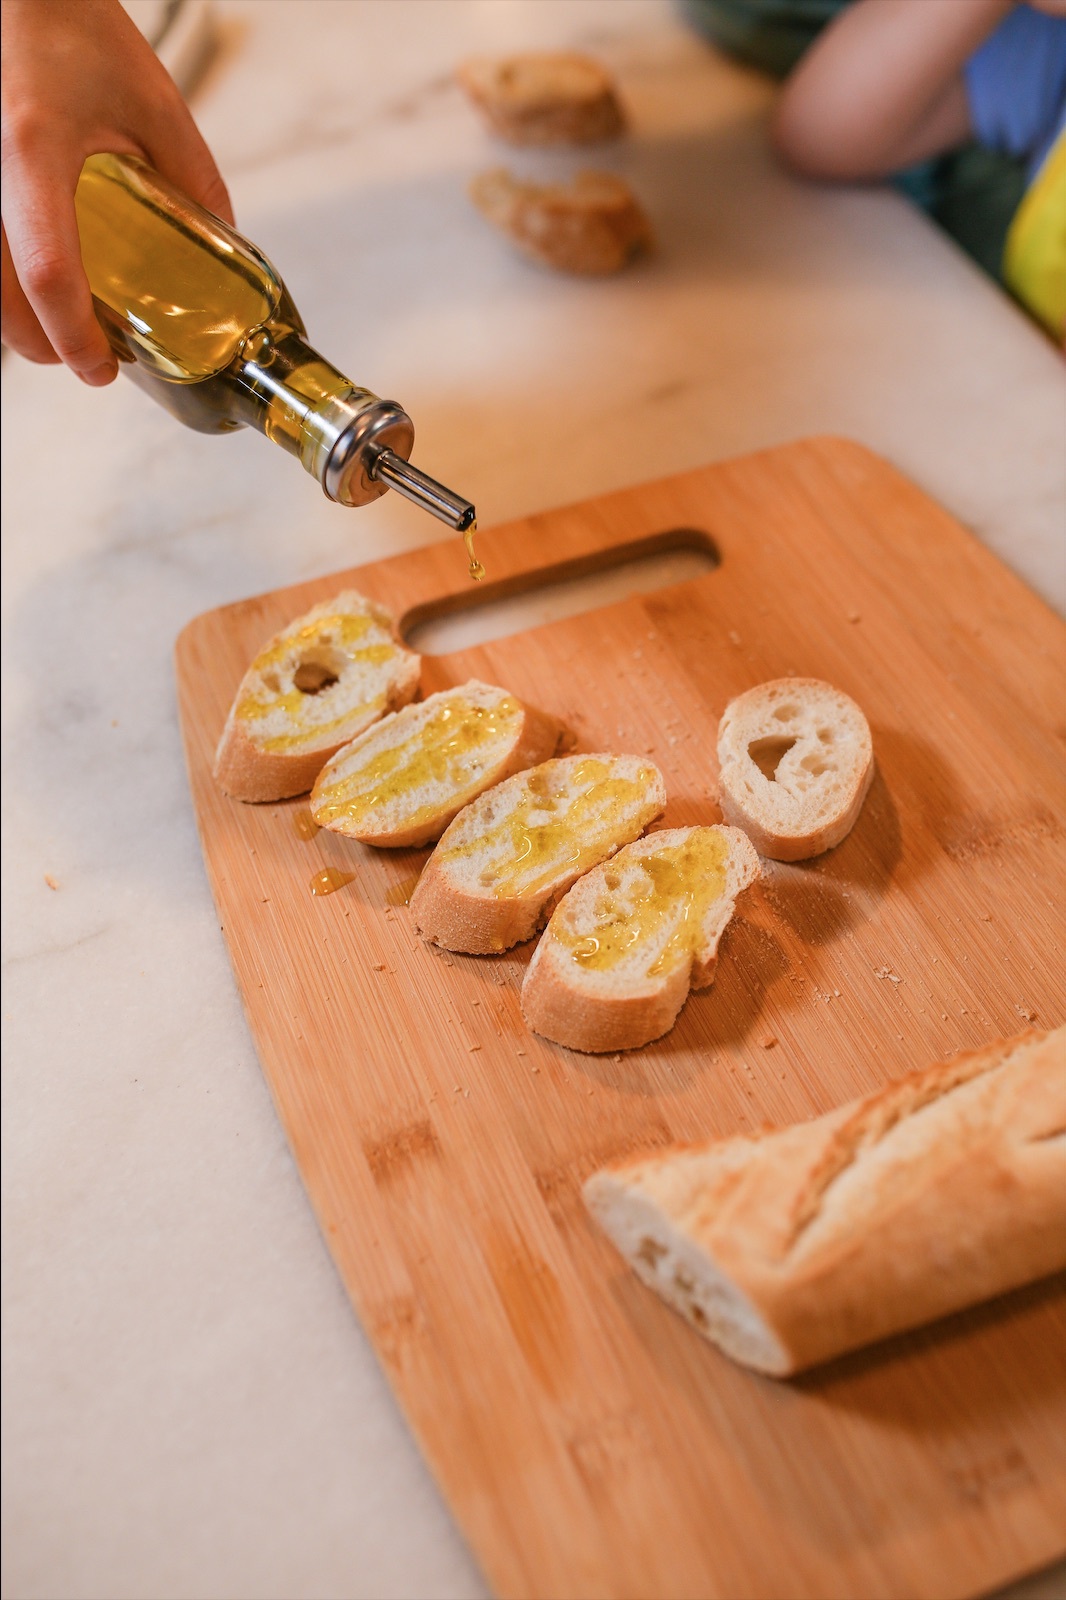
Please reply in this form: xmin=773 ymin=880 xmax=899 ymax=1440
xmin=213 ymin=590 xmax=423 ymax=805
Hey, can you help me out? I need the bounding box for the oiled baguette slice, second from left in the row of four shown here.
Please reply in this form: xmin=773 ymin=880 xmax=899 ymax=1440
xmin=311 ymin=678 xmax=562 ymax=846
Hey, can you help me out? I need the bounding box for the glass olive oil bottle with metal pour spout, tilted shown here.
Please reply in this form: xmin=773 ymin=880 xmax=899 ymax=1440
xmin=75 ymin=155 xmax=474 ymax=533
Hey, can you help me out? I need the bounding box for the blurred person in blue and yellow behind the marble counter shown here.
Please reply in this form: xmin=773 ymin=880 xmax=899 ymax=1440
xmin=683 ymin=0 xmax=1066 ymax=342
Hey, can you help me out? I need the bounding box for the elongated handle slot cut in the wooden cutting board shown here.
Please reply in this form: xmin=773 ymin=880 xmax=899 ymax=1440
xmin=400 ymin=528 xmax=722 ymax=656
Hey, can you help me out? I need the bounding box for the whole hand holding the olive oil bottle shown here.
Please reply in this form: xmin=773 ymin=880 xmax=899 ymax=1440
xmin=0 ymin=0 xmax=232 ymax=384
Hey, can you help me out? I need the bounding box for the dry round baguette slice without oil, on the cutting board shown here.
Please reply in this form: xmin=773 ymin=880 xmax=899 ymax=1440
xmin=719 ymin=678 xmax=874 ymax=861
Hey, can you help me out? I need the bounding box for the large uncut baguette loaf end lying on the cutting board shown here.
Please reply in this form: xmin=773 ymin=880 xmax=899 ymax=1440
xmin=584 ymin=1027 xmax=1066 ymax=1376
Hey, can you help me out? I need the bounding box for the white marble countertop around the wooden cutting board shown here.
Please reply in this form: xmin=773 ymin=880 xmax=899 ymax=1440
xmin=3 ymin=0 xmax=1066 ymax=1600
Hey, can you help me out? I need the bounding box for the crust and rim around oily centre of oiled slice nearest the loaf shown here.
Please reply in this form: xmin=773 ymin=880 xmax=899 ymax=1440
xmin=522 ymin=827 xmax=759 ymax=1054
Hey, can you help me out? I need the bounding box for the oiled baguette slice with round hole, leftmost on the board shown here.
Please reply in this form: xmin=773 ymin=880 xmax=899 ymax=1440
xmin=214 ymin=589 xmax=421 ymax=802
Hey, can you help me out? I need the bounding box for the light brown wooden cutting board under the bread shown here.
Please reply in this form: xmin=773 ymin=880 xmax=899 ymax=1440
xmin=178 ymin=440 xmax=1066 ymax=1600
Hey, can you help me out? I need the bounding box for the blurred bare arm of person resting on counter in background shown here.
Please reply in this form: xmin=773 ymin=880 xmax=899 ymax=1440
xmin=773 ymin=0 xmax=1013 ymax=179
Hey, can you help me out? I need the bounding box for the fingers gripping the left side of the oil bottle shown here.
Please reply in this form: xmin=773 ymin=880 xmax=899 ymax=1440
xmin=3 ymin=139 xmax=118 ymax=386
